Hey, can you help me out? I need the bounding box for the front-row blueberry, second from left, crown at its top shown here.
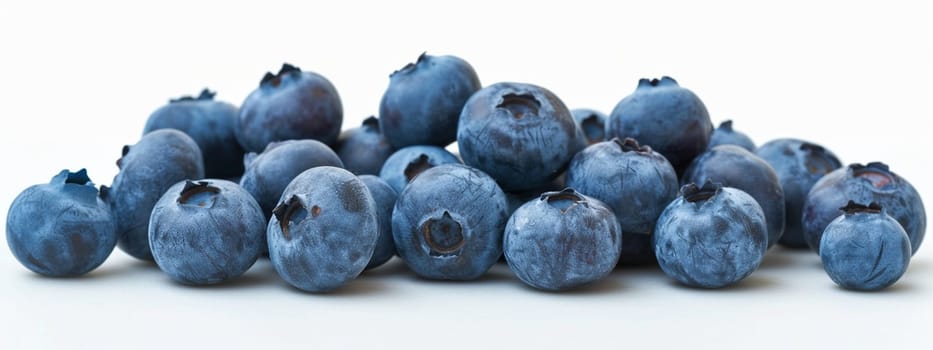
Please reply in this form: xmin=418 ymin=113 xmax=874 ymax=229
xmin=149 ymin=179 xmax=266 ymax=285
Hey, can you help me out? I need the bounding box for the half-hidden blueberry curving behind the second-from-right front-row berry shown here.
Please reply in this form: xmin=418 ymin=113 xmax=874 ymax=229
xmin=682 ymin=145 xmax=786 ymax=248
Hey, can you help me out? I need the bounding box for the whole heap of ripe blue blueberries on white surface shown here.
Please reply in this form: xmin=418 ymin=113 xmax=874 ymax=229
xmin=6 ymin=54 xmax=926 ymax=292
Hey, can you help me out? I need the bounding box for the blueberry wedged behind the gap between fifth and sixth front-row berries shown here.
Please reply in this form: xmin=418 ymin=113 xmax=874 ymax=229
xmin=567 ymin=138 xmax=678 ymax=263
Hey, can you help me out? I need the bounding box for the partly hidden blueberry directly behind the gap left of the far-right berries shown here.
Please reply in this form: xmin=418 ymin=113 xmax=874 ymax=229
xmin=755 ymin=139 xmax=842 ymax=248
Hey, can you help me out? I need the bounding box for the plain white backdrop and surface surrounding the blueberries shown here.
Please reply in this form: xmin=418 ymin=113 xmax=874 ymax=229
xmin=0 ymin=0 xmax=933 ymax=349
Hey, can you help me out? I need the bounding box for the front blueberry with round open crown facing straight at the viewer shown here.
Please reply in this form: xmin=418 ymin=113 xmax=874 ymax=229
xmin=392 ymin=164 xmax=508 ymax=280
